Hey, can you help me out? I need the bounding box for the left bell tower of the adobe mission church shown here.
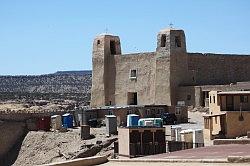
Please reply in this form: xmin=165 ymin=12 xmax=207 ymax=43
xmin=91 ymin=34 xmax=121 ymax=107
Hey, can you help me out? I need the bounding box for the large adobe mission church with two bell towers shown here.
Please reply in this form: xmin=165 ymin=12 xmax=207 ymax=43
xmin=91 ymin=28 xmax=250 ymax=108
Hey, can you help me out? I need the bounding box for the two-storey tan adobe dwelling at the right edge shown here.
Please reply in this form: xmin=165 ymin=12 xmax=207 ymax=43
xmin=204 ymin=91 xmax=250 ymax=139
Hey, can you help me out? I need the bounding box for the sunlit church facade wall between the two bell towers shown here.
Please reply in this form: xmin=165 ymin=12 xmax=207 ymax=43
xmin=115 ymin=52 xmax=155 ymax=105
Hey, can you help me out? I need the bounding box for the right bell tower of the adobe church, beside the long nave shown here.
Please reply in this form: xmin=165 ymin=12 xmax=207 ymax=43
xmin=155 ymin=28 xmax=188 ymax=105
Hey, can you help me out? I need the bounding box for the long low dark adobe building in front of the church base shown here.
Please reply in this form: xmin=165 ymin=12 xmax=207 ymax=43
xmin=81 ymin=105 xmax=188 ymax=126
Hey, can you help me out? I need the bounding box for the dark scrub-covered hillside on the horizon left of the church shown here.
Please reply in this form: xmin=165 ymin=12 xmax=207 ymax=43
xmin=0 ymin=70 xmax=91 ymax=94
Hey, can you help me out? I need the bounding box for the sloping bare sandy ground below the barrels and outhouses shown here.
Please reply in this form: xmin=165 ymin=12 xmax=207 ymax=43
xmin=14 ymin=127 xmax=114 ymax=166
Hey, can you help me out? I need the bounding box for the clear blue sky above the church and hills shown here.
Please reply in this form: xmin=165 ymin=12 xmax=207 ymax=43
xmin=0 ymin=0 xmax=250 ymax=75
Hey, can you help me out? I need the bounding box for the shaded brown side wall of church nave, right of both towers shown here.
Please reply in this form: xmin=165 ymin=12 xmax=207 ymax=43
xmin=188 ymin=53 xmax=250 ymax=85
